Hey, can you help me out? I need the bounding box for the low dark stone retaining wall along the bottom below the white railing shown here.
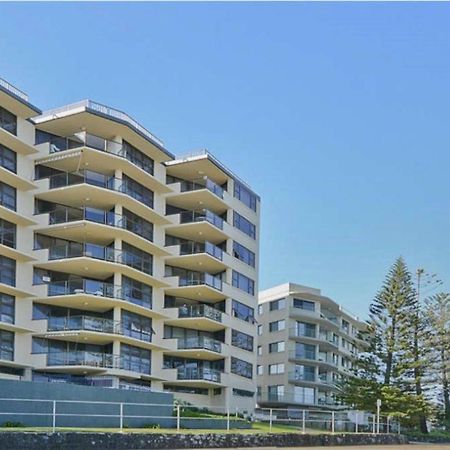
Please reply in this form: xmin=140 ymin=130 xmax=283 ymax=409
xmin=0 ymin=431 xmax=408 ymax=450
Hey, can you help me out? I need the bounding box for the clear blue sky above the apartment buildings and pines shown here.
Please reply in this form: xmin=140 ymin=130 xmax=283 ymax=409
xmin=0 ymin=3 xmax=450 ymax=316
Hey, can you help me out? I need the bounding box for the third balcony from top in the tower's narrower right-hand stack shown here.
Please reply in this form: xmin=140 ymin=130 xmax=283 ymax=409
xmin=166 ymin=241 xmax=228 ymax=272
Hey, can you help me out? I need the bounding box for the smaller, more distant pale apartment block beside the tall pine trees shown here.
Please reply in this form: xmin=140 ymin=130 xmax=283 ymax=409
xmin=257 ymin=283 xmax=364 ymax=409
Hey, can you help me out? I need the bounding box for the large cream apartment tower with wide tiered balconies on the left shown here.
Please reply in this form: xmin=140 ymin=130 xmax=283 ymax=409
xmin=0 ymin=76 xmax=260 ymax=410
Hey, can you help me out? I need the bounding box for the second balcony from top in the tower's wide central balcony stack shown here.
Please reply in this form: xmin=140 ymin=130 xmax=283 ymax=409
xmin=36 ymin=170 xmax=165 ymax=224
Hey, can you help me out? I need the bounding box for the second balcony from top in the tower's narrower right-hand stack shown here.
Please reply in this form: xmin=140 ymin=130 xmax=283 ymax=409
xmin=167 ymin=209 xmax=228 ymax=244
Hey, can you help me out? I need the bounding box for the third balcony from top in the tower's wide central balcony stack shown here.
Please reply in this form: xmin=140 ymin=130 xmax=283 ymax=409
xmin=39 ymin=205 xmax=168 ymax=255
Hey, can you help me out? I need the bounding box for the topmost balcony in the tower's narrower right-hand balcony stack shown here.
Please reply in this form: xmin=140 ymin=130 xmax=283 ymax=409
xmin=166 ymin=177 xmax=228 ymax=213
